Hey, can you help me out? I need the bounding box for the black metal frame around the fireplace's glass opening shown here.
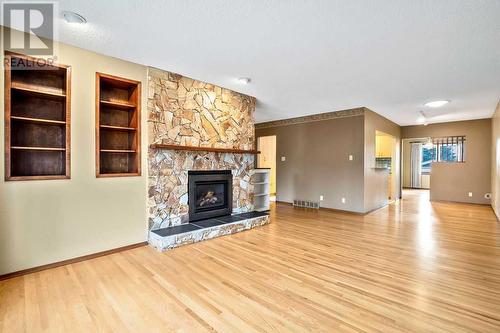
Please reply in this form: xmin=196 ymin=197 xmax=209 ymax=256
xmin=188 ymin=170 xmax=233 ymax=222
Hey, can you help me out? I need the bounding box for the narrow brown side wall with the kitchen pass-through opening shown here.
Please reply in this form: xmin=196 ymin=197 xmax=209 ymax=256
xmin=364 ymin=108 xmax=401 ymax=212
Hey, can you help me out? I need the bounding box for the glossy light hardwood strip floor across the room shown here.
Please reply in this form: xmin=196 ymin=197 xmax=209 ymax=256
xmin=0 ymin=191 xmax=500 ymax=333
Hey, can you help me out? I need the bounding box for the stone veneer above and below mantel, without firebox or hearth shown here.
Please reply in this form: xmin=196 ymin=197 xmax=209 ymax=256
xmin=148 ymin=68 xmax=255 ymax=229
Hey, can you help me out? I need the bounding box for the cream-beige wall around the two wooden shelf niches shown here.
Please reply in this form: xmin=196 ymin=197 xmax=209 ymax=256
xmin=0 ymin=28 xmax=147 ymax=275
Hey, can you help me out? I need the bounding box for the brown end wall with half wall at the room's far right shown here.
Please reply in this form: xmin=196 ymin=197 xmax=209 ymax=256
xmin=401 ymin=119 xmax=491 ymax=204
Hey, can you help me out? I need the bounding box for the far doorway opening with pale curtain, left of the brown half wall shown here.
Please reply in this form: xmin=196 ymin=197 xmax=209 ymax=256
xmin=403 ymin=138 xmax=433 ymax=190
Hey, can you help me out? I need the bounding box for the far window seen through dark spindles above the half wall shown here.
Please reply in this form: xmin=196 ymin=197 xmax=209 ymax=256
xmin=422 ymin=136 xmax=465 ymax=173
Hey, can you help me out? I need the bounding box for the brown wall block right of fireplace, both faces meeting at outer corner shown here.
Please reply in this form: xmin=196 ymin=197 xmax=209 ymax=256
xmin=255 ymin=108 xmax=401 ymax=213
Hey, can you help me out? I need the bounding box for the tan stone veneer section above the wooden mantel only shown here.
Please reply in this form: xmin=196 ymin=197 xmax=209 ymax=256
xmin=148 ymin=68 xmax=255 ymax=149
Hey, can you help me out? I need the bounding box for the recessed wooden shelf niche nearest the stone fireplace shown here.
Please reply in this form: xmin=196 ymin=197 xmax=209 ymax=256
xmin=96 ymin=73 xmax=141 ymax=177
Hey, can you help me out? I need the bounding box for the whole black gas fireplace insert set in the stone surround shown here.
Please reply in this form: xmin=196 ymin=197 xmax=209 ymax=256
xmin=188 ymin=170 xmax=233 ymax=222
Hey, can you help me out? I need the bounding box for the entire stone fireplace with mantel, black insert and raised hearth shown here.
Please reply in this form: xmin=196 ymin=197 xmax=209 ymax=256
xmin=148 ymin=68 xmax=269 ymax=251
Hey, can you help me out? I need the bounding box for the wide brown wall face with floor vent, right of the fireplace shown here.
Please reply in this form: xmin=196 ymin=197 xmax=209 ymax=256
xmin=256 ymin=115 xmax=366 ymax=212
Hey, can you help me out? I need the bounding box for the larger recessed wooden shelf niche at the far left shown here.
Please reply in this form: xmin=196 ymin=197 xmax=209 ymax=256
xmin=5 ymin=52 xmax=71 ymax=180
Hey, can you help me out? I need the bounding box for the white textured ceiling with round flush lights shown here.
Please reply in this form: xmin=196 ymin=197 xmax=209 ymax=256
xmin=11 ymin=0 xmax=500 ymax=125
